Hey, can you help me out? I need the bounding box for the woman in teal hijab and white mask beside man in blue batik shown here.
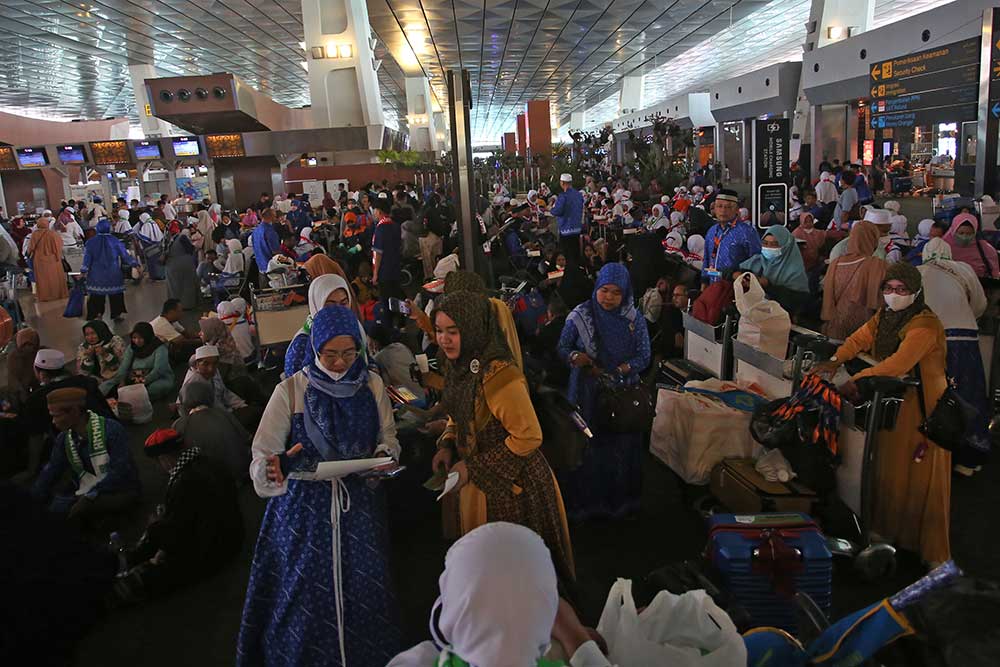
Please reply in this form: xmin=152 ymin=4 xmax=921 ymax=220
xmin=740 ymin=225 xmax=811 ymax=313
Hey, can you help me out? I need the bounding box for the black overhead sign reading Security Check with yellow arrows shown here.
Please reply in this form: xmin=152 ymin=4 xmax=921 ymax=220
xmin=869 ymin=37 xmax=981 ymax=129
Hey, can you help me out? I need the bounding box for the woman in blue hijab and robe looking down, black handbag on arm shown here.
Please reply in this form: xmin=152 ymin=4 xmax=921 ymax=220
xmin=559 ymin=263 xmax=650 ymax=520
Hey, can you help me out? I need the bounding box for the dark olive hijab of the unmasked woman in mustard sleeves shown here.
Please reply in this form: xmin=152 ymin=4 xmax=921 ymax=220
xmin=431 ymin=291 xmax=511 ymax=447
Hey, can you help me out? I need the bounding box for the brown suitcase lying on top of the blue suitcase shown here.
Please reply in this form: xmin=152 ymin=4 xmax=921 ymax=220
xmin=710 ymin=459 xmax=816 ymax=514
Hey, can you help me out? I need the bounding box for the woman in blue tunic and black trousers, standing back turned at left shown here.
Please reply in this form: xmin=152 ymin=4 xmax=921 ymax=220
xmin=80 ymin=218 xmax=139 ymax=322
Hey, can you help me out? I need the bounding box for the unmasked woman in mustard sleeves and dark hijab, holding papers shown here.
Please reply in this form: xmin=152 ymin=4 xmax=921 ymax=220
xmin=432 ymin=291 xmax=575 ymax=581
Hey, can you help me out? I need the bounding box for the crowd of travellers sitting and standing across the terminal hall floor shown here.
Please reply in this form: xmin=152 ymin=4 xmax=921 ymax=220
xmin=0 ymin=165 xmax=1000 ymax=667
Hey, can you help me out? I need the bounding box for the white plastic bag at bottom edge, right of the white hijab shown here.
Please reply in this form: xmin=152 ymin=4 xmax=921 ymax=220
xmin=597 ymin=579 xmax=747 ymax=667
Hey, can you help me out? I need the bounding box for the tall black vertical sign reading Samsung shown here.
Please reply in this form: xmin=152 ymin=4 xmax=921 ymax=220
xmin=754 ymin=118 xmax=792 ymax=228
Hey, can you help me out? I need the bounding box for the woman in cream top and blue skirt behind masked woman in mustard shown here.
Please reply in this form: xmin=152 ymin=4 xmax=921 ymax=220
xmin=917 ymin=239 xmax=990 ymax=476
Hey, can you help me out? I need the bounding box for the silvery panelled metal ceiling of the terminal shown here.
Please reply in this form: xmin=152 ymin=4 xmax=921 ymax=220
xmin=0 ymin=0 xmax=960 ymax=143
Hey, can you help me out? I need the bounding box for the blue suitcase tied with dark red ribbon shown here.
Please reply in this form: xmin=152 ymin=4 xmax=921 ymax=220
xmin=707 ymin=512 xmax=833 ymax=633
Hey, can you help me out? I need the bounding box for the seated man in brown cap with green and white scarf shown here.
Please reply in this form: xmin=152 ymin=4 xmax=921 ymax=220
xmin=32 ymin=387 xmax=139 ymax=520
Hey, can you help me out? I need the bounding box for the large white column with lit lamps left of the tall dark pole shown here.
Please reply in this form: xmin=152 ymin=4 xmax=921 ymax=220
xmin=302 ymin=0 xmax=385 ymax=150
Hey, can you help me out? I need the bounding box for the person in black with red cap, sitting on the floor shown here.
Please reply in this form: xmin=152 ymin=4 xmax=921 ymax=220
xmin=115 ymin=429 xmax=245 ymax=601
